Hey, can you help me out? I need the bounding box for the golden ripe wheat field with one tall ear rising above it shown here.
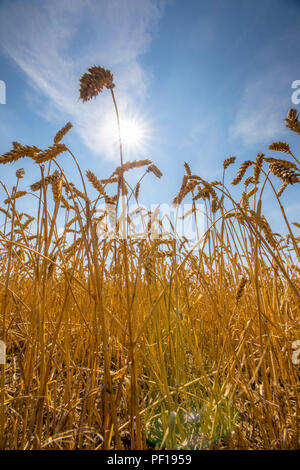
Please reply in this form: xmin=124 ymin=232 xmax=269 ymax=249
xmin=0 ymin=66 xmax=300 ymax=449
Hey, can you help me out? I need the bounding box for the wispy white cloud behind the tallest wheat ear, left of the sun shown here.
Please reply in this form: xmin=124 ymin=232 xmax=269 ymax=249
xmin=0 ymin=0 xmax=166 ymax=159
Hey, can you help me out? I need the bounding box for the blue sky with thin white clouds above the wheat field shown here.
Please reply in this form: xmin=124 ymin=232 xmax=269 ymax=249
xmin=0 ymin=0 xmax=300 ymax=235
